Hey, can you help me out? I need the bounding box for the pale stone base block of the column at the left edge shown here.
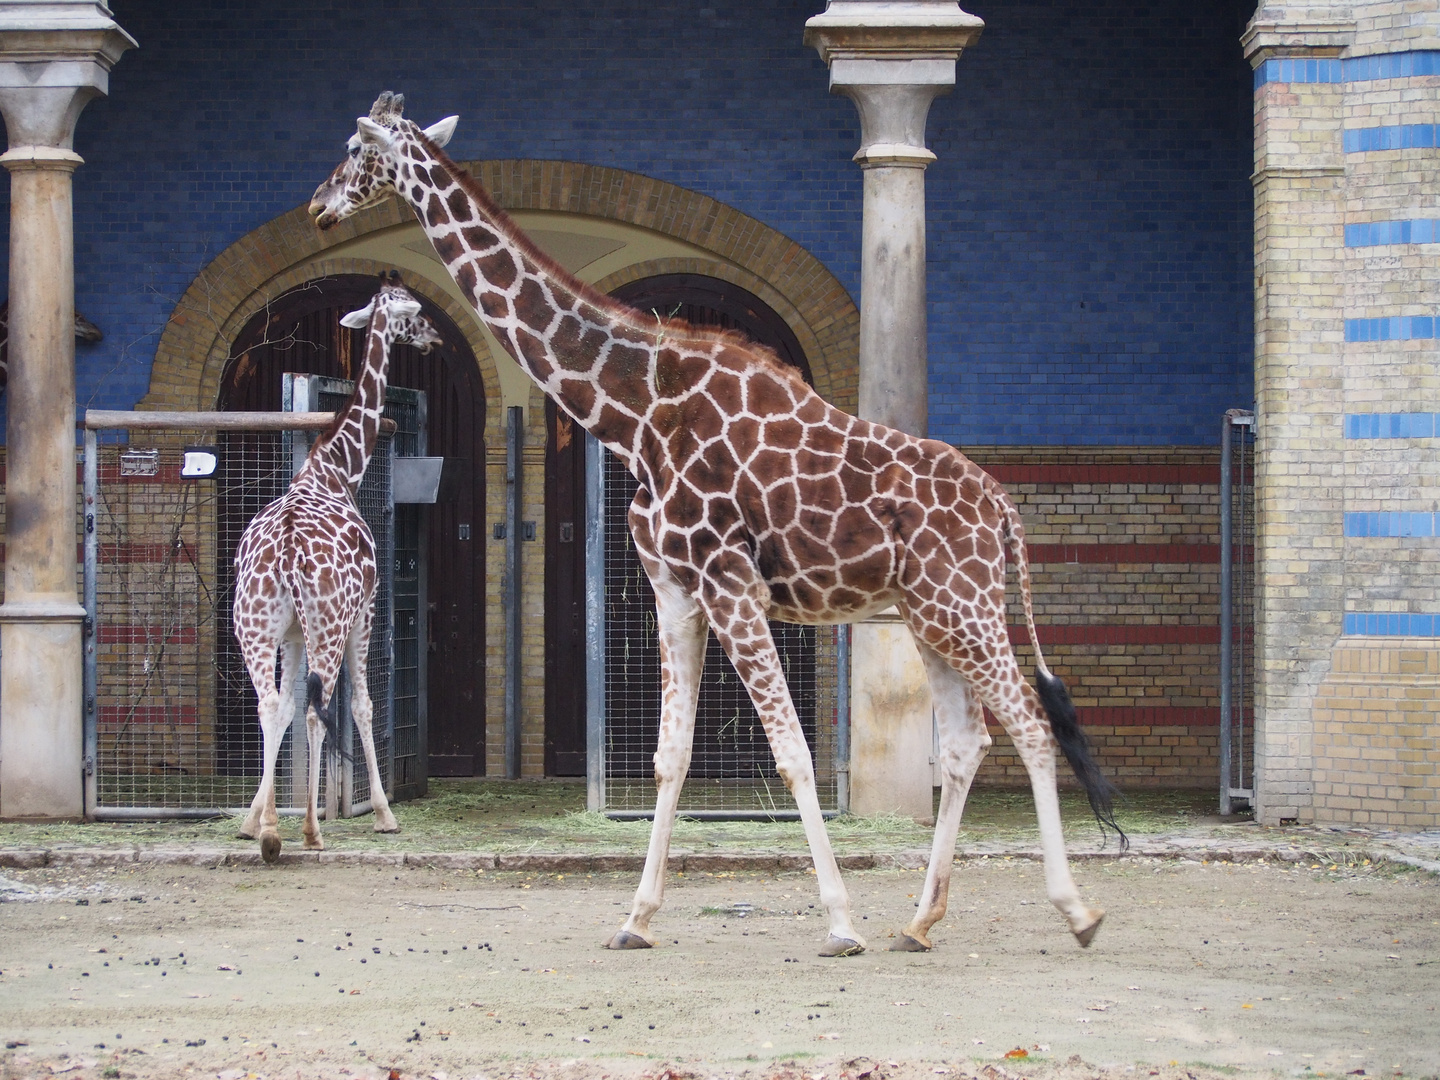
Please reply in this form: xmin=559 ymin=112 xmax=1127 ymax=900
xmin=0 ymin=603 xmax=85 ymax=821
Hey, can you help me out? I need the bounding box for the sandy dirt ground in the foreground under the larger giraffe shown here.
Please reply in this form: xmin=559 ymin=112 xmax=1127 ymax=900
xmin=0 ymin=857 xmax=1440 ymax=1080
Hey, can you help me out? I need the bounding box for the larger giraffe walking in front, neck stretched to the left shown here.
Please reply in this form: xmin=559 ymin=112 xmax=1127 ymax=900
xmin=310 ymin=92 xmax=1113 ymax=956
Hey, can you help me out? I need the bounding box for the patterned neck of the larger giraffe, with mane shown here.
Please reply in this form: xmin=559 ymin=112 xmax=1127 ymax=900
xmin=395 ymin=132 xmax=665 ymax=464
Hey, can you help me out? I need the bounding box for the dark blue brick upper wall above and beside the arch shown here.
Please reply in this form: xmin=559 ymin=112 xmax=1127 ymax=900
xmin=0 ymin=0 xmax=1254 ymax=445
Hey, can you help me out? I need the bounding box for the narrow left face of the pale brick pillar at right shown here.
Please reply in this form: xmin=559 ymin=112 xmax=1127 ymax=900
xmin=1241 ymin=1 xmax=1355 ymax=825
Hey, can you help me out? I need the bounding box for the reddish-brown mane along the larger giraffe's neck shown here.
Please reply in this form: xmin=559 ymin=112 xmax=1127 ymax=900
xmin=417 ymin=127 xmax=808 ymax=387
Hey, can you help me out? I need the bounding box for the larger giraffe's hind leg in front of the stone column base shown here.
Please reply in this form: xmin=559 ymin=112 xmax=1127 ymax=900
xmin=890 ymin=641 xmax=991 ymax=952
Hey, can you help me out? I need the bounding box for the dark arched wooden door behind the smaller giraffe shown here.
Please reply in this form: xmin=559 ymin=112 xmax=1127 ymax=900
xmin=217 ymin=274 xmax=485 ymax=798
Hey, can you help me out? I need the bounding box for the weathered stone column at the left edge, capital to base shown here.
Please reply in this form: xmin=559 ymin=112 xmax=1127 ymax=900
xmin=0 ymin=0 xmax=134 ymax=818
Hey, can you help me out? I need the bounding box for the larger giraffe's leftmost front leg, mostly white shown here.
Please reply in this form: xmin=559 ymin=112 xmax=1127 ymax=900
xmin=609 ymin=567 xmax=707 ymax=949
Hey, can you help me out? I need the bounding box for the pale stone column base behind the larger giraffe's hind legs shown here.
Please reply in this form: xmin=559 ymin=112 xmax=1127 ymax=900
xmin=850 ymin=608 xmax=935 ymax=825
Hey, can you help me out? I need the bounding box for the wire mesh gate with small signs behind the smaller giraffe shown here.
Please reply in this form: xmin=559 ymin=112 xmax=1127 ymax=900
xmin=84 ymin=410 xmax=393 ymax=819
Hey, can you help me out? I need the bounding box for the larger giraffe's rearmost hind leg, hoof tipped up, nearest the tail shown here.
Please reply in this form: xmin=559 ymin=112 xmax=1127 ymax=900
xmin=976 ymin=642 xmax=1104 ymax=946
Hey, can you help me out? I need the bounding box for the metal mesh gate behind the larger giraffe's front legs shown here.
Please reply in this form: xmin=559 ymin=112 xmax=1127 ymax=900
xmin=586 ymin=439 xmax=850 ymax=818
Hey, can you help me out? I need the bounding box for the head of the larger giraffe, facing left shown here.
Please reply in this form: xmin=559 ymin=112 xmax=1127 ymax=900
xmin=310 ymin=91 xmax=459 ymax=229
